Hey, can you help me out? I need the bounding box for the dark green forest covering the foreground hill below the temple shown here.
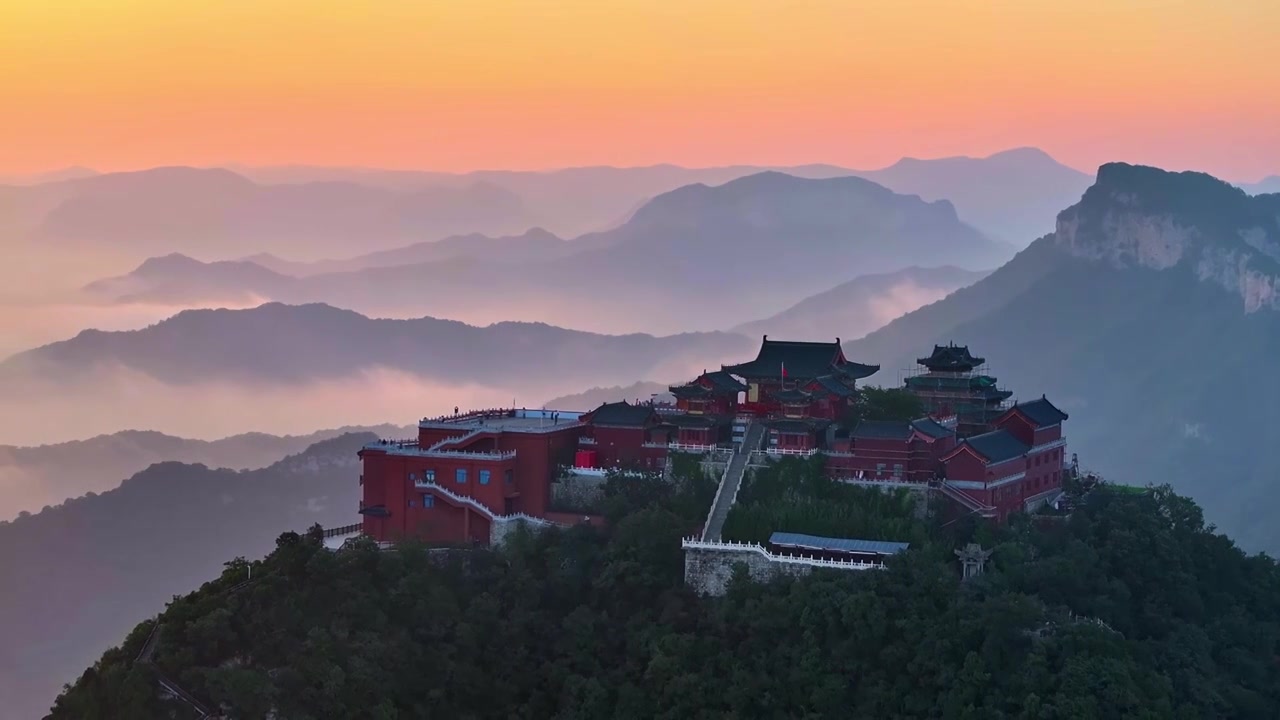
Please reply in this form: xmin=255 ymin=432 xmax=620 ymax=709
xmin=49 ymin=468 xmax=1280 ymax=720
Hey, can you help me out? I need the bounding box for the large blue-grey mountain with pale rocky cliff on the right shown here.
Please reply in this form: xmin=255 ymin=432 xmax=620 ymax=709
xmin=846 ymin=164 xmax=1280 ymax=553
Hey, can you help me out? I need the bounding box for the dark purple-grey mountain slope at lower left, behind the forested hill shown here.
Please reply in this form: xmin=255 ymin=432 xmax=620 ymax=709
xmin=0 ymin=434 xmax=376 ymax=717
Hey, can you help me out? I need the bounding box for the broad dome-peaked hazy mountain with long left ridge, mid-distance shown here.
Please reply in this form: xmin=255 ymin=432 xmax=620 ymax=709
xmin=85 ymin=172 xmax=1012 ymax=333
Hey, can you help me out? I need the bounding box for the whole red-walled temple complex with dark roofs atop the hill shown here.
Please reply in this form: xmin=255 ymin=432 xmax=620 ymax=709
xmin=348 ymin=336 xmax=1068 ymax=543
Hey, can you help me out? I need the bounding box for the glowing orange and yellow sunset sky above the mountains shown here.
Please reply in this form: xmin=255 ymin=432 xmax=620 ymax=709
xmin=0 ymin=0 xmax=1280 ymax=181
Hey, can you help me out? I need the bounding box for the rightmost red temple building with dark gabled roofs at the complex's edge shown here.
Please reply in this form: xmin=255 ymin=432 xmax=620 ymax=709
xmin=942 ymin=396 xmax=1068 ymax=520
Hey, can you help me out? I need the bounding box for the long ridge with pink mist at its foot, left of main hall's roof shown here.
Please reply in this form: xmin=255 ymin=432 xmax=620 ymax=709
xmin=0 ymin=304 xmax=754 ymax=445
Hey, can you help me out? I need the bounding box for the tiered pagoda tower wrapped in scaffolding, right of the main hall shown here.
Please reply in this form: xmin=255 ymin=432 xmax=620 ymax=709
xmin=905 ymin=343 xmax=1012 ymax=437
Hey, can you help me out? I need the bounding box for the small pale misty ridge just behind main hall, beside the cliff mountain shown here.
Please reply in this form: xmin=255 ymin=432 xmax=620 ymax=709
xmin=730 ymin=266 xmax=987 ymax=338
